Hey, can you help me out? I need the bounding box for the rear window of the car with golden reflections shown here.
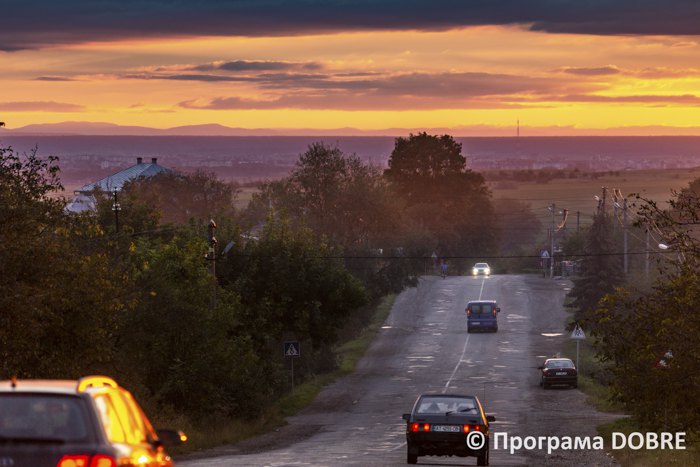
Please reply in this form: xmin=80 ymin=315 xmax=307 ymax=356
xmin=0 ymin=393 xmax=88 ymax=442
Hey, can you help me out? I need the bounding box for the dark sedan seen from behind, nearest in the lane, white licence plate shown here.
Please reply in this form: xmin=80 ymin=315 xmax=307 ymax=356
xmin=403 ymin=394 xmax=496 ymax=465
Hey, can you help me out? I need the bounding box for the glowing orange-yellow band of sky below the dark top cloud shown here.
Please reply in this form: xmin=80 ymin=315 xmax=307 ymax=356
xmin=0 ymin=5 xmax=700 ymax=136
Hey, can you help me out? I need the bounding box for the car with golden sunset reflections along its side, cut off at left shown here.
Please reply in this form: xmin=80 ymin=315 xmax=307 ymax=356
xmin=0 ymin=376 xmax=186 ymax=467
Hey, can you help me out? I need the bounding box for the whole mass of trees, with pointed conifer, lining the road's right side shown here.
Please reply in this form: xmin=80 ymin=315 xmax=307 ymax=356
xmin=570 ymin=179 xmax=700 ymax=433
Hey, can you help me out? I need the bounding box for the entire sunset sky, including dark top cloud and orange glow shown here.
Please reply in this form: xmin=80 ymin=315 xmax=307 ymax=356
xmin=0 ymin=0 xmax=700 ymax=136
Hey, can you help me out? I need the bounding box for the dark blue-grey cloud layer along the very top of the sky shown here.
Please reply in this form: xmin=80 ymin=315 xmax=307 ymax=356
xmin=0 ymin=0 xmax=700 ymax=51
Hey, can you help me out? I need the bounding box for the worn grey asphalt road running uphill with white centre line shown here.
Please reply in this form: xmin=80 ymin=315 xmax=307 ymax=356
xmin=177 ymin=275 xmax=615 ymax=467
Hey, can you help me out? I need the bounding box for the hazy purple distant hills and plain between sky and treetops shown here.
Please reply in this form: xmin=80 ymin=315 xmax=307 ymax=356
xmin=0 ymin=122 xmax=700 ymax=187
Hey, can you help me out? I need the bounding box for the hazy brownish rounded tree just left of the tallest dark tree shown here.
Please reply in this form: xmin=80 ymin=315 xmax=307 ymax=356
xmin=244 ymin=143 xmax=424 ymax=297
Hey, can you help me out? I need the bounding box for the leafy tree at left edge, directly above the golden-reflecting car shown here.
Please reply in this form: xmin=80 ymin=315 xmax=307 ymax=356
xmin=0 ymin=148 xmax=123 ymax=377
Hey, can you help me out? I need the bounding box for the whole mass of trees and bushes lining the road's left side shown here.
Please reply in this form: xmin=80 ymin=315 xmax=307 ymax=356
xmin=0 ymin=136 xmax=504 ymax=428
